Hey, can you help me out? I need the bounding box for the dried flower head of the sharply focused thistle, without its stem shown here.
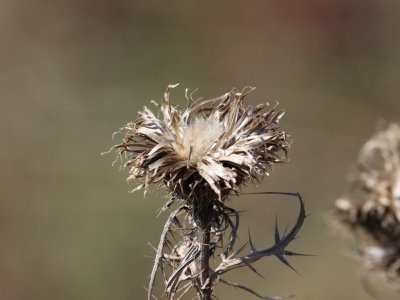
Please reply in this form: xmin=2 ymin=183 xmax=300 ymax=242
xmin=114 ymin=85 xmax=289 ymax=205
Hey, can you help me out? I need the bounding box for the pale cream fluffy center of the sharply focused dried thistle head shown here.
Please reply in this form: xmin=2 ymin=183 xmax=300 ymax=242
xmin=174 ymin=118 xmax=224 ymax=163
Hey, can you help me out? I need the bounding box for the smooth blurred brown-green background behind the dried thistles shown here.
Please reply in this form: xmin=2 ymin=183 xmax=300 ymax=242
xmin=0 ymin=0 xmax=400 ymax=300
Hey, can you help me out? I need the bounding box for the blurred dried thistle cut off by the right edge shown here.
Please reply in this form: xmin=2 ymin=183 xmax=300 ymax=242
xmin=336 ymin=124 xmax=400 ymax=291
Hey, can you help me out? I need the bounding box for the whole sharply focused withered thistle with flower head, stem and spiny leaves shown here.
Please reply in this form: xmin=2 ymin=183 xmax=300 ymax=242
xmin=108 ymin=85 xmax=305 ymax=300
